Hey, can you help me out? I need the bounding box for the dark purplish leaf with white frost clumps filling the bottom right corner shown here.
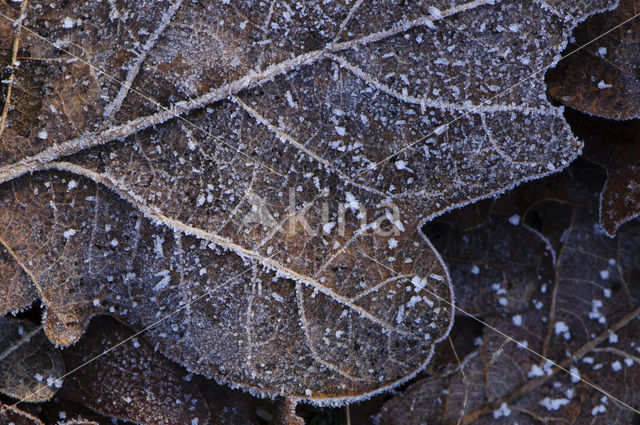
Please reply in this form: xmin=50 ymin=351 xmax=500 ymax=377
xmin=379 ymin=170 xmax=640 ymax=425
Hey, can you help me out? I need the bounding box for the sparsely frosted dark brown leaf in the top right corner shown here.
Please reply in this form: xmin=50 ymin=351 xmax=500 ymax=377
xmin=547 ymin=0 xmax=640 ymax=119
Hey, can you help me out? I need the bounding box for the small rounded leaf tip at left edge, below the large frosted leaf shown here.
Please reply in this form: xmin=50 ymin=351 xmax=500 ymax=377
xmin=0 ymin=317 xmax=64 ymax=402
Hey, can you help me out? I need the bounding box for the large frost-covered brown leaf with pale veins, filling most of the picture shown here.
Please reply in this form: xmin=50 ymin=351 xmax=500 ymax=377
xmin=0 ymin=0 xmax=614 ymax=403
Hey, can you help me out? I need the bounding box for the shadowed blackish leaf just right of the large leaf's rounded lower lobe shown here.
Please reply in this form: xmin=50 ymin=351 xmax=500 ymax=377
xmin=425 ymin=215 xmax=555 ymax=317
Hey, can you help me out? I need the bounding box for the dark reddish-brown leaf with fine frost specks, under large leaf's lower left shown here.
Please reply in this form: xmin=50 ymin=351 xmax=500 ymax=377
xmin=60 ymin=317 xmax=209 ymax=425
